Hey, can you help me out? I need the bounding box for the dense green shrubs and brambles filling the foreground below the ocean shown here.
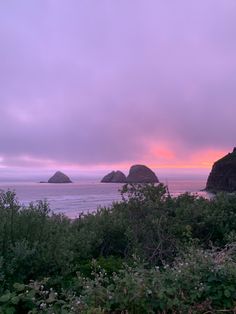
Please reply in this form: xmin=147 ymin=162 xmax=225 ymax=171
xmin=0 ymin=185 xmax=236 ymax=314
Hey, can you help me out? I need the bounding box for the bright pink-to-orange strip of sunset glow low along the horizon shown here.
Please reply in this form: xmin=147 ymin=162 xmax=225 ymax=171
xmin=0 ymin=149 xmax=228 ymax=172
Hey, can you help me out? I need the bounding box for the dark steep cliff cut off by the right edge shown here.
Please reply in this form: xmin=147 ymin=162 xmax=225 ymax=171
xmin=206 ymin=147 xmax=236 ymax=193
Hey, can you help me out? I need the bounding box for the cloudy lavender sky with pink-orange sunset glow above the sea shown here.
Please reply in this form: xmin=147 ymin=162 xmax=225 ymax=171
xmin=0 ymin=0 xmax=236 ymax=176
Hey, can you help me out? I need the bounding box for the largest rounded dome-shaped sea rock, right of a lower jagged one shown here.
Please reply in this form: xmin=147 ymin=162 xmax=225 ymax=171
xmin=127 ymin=165 xmax=159 ymax=183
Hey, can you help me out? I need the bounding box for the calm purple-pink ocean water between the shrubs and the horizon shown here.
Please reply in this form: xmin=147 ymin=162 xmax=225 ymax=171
xmin=0 ymin=175 xmax=209 ymax=218
